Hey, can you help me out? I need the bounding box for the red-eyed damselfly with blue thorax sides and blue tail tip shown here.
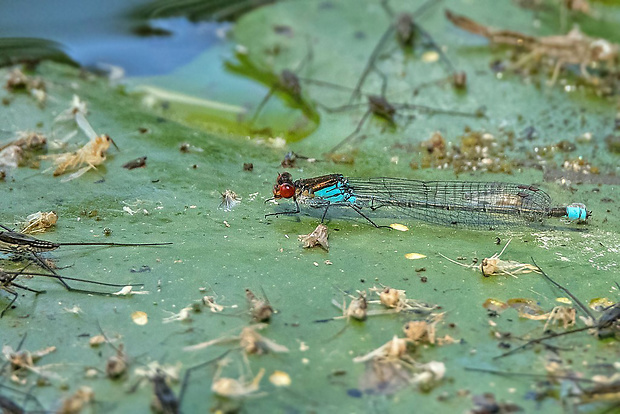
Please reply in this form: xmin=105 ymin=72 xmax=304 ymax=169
xmin=266 ymin=172 xmax=591 ymax=230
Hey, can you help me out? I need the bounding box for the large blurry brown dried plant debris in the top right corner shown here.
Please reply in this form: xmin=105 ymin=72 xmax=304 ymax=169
xmin=446 ymin=10 xmax=619 ymax=85
